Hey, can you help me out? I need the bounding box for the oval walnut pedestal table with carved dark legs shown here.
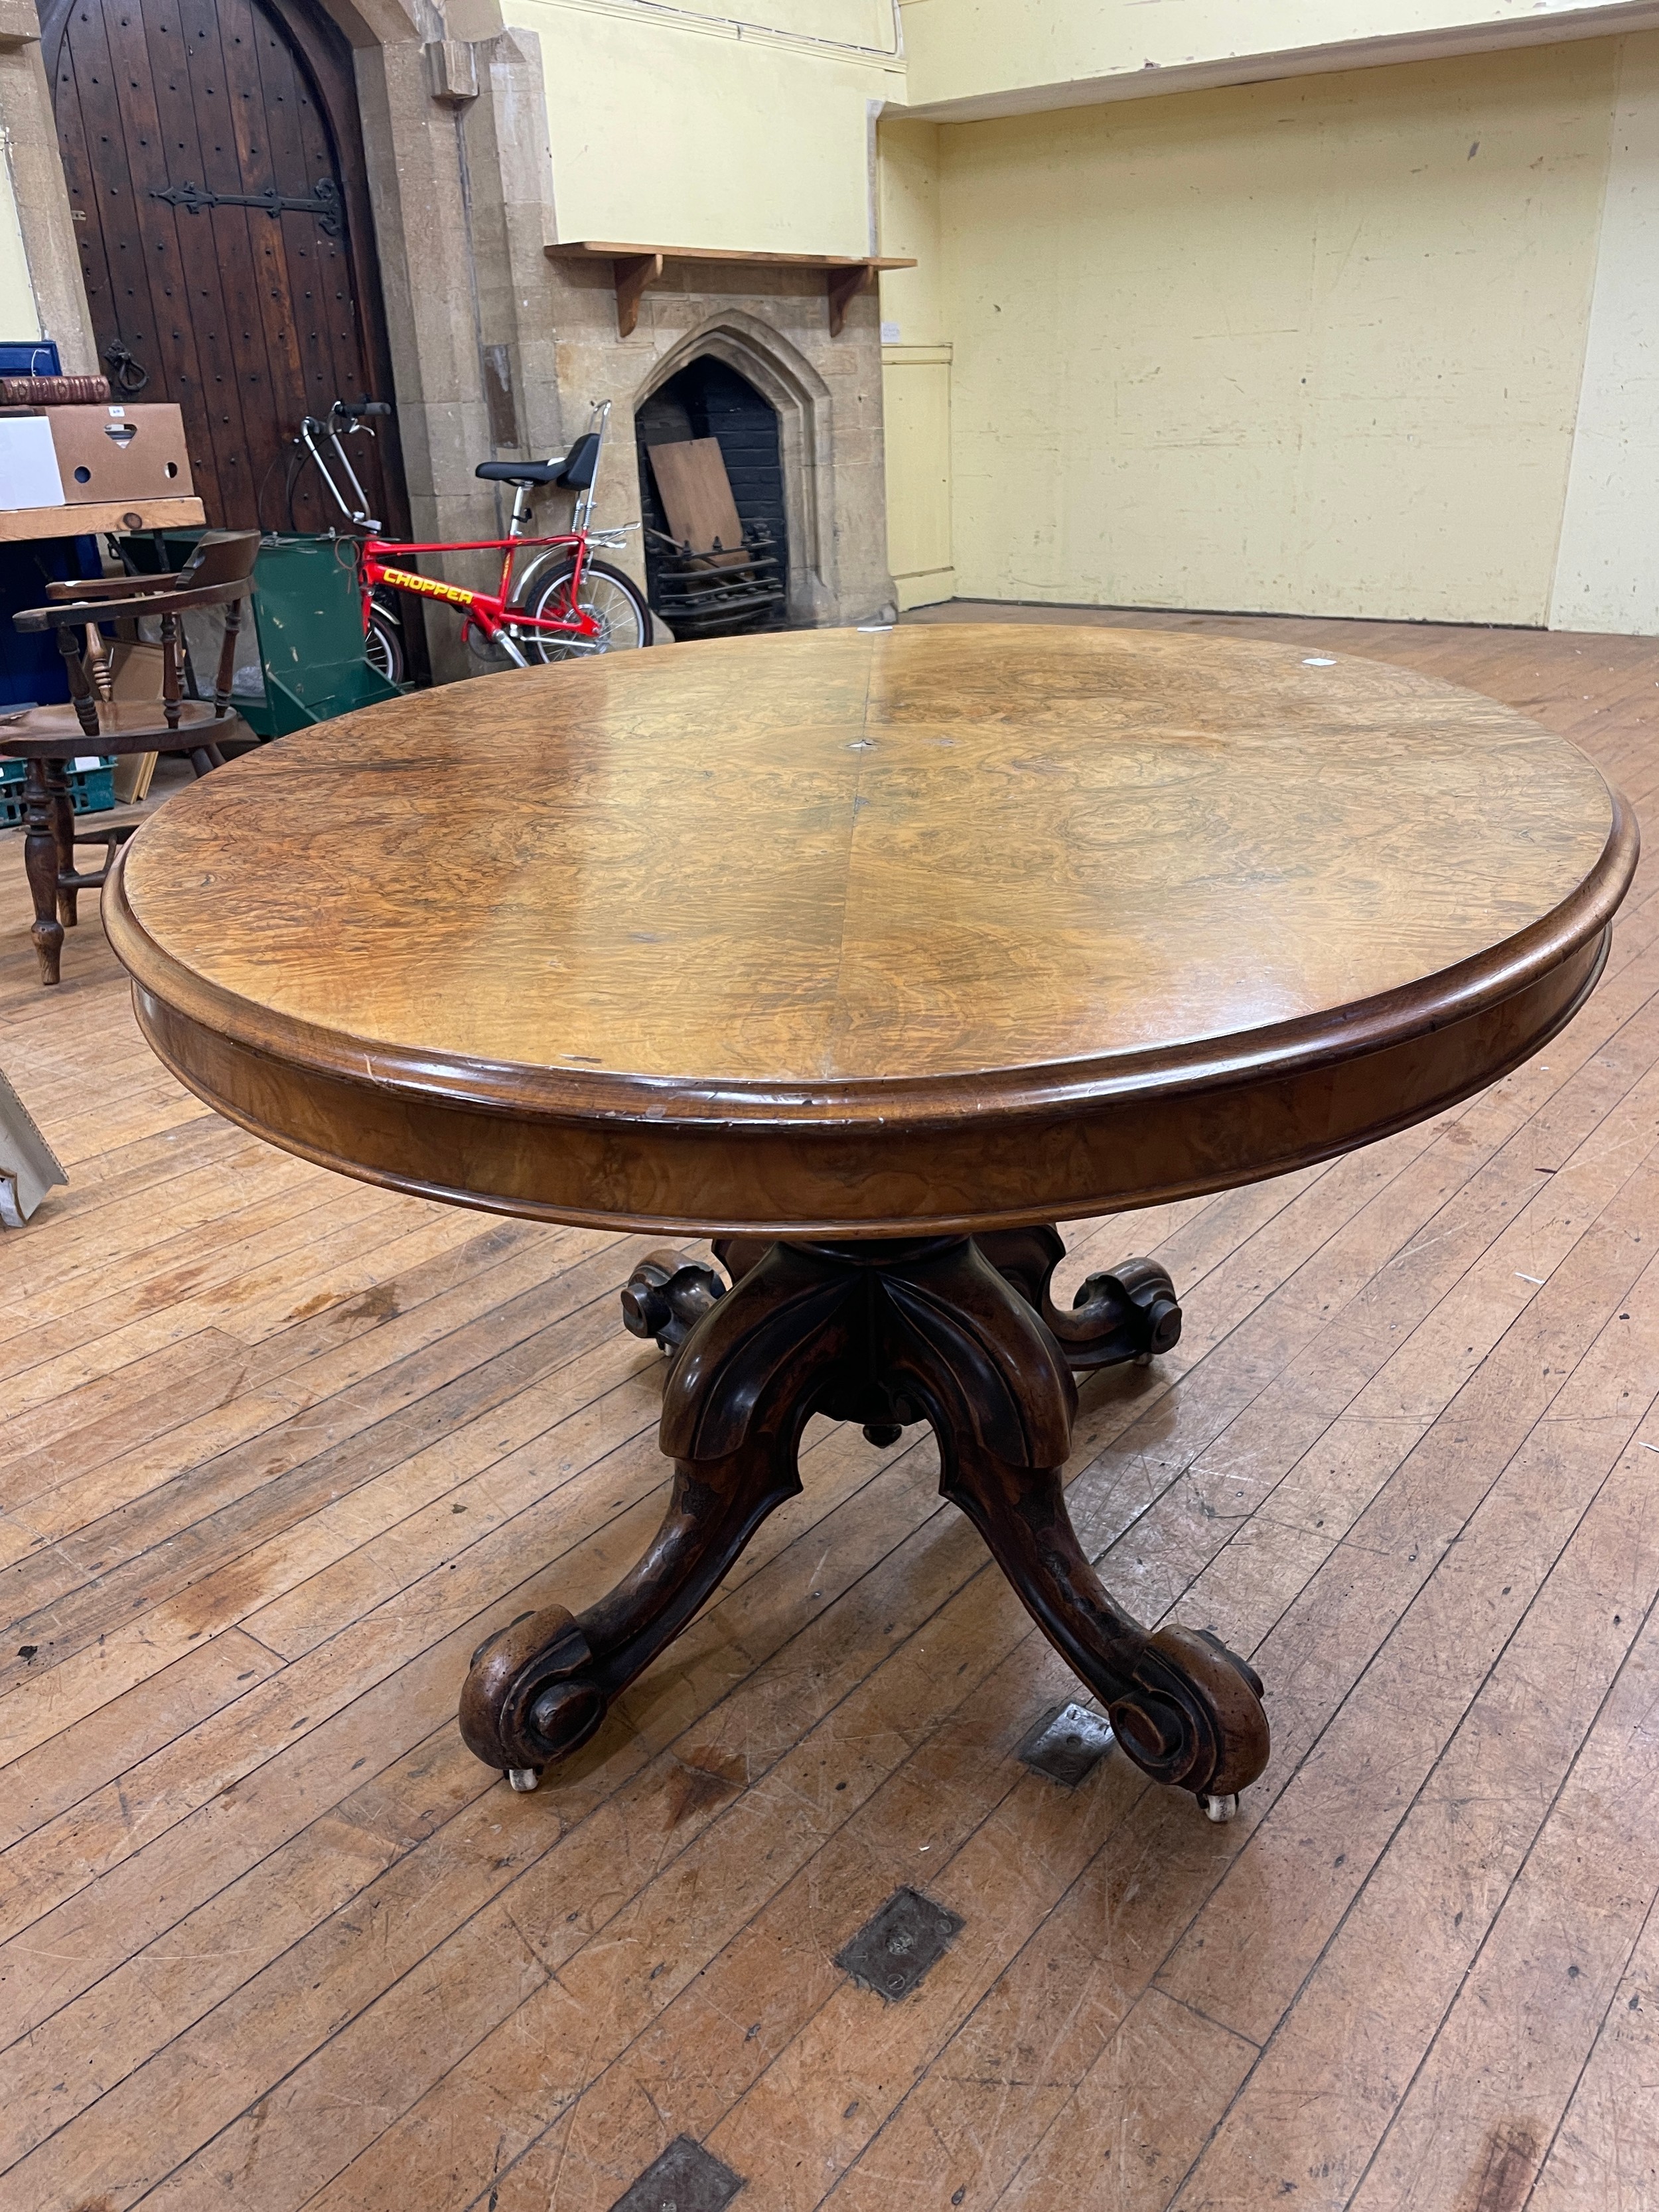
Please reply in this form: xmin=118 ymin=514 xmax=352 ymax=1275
xmin=104 ymin=626 xmax=1637 ymax=1818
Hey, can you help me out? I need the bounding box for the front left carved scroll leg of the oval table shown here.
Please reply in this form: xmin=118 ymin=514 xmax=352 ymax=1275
xmin=460 ymin=1254 xmax=847 ymax=1789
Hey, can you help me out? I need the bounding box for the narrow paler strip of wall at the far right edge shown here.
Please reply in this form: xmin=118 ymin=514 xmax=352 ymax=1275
xmin=1548 ymin=35 xmax=1659 ymax=635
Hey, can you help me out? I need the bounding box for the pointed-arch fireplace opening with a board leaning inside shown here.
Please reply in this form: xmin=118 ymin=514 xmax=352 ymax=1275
xmin=635 ymin=354 xmax=790 ymax=637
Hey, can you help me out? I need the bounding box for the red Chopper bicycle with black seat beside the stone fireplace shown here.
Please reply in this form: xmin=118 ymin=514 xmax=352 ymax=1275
xmin=287 ymin=400 xmax=650 ymax=684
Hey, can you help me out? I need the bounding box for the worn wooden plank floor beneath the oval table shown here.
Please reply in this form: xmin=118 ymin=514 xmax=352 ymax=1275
xmin=0 ymin=606 xmax=1659 ymax=2212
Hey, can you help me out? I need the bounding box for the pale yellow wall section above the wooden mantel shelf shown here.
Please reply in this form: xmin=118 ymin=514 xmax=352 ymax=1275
xmin=522 ymin=0 xmax=904 ymax=254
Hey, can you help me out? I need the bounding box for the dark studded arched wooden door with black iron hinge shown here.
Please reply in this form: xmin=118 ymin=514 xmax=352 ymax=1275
xmin=42 ymin=0 xmax=407 ymax=531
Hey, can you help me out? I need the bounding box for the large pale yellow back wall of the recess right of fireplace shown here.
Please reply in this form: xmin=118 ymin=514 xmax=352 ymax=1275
xmin=911 ymin=45 xmax=1619 ymax=622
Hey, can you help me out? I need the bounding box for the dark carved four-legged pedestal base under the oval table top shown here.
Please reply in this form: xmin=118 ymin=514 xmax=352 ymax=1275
xmin=460 ymin=1228 xmax=1267 ymax=1818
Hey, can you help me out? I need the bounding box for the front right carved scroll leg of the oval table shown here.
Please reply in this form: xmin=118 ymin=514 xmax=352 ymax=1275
xmin=889 ymin=1256 xmax=1267 ymax=1818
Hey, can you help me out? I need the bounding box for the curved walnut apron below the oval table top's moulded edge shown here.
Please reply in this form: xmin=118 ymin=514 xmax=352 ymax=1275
xmin=133 ymin=931 xmax=1611 ymax=1236
